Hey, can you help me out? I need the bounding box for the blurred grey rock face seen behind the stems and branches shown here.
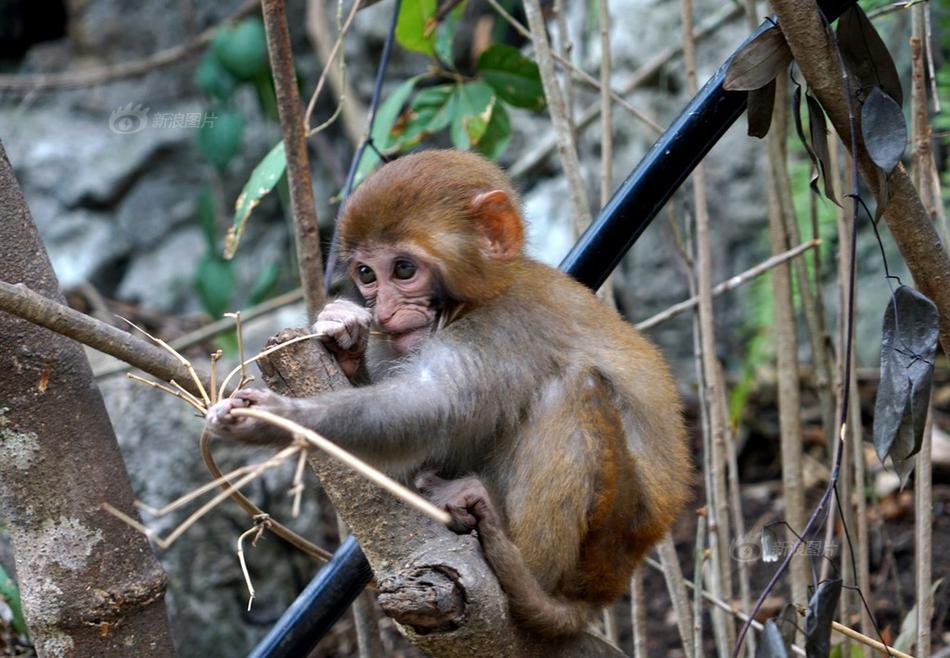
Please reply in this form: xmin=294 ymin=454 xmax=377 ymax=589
xmin=0 ymin=0 xmax=936 ymax=658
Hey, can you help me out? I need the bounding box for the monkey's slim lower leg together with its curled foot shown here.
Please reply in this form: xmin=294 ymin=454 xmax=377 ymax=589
xmin=416 ymin=473 xmax=596 ymax=636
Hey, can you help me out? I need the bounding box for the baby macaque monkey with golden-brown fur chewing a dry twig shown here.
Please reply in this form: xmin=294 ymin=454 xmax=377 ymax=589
xmin=207 ymin=151 xmax=692 ymax=637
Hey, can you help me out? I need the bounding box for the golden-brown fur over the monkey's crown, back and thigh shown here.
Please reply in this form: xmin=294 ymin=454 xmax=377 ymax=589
xmin=340 ymin=151 xmax=691 ymax=634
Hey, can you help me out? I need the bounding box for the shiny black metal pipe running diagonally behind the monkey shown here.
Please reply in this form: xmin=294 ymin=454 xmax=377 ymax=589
xmin=250 ymin=0 xmax=855 ymax=658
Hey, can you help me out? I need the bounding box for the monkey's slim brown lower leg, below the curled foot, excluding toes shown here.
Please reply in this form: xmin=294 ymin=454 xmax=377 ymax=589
xmin=479 ymin=524 xmax=596 ymax=637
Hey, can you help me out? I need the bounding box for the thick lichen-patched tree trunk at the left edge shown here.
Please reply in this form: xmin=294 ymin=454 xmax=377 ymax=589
xmin=0 ymin=145 xmax=175 ymax=658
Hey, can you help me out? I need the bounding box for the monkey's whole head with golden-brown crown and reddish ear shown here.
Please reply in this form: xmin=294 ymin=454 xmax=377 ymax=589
xmin=339 ymin=151 xmax=524 ymax=352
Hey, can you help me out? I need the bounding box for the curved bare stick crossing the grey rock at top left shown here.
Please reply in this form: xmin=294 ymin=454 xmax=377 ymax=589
xmin=0 ymin=0 xmax=258 ymax=93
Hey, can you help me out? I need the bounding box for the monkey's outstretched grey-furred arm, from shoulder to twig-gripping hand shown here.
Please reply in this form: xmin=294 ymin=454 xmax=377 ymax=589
xmin=207 ymin=340 xmax=540 ymax=464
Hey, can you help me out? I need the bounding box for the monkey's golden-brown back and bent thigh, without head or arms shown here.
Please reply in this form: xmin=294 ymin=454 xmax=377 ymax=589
xmin=484 ymin=260 xmax=692 ymax=605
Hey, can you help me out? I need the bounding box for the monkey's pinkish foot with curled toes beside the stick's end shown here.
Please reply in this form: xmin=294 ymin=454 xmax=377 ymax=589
xmin=415 ymin=471 xmax=501 ymax=533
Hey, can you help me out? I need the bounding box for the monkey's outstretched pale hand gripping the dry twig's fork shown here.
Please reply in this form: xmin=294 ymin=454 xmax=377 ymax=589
xmin=205 ymin=388 xmax=293 ymax=445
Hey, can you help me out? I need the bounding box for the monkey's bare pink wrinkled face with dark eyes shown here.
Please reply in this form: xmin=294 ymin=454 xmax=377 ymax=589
xmin=350 ymin=245 xmax=439 ymax=354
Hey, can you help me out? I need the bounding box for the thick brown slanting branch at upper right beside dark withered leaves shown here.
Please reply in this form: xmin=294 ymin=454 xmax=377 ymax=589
xmin=772 ymin=0 xmax=950 ymax=353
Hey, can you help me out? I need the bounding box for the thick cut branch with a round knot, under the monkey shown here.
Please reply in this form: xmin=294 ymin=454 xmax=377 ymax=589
xmin=261 ymin=329 xmax=623 ymax=658
